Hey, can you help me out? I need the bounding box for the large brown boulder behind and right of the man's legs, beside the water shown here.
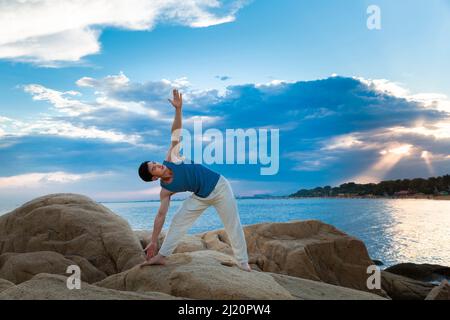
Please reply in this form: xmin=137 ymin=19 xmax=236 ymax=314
xmin=201 ymin=220 xmax=382 ymax=294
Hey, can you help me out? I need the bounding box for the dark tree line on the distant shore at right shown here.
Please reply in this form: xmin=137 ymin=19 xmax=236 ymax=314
xmin=289 ymin=175 xmax=450 ymax=197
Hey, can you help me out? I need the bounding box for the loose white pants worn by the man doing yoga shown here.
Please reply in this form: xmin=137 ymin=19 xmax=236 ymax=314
xmin=159 ymin=176 xmax=248 ymax=263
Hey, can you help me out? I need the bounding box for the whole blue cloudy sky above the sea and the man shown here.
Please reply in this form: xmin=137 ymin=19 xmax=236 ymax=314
xmin=0 ymin=0 xmax=450 ymax=208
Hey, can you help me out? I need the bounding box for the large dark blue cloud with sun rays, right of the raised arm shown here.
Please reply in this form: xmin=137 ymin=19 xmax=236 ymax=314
xmin=208 ymin=76 xmax=450 ymax=186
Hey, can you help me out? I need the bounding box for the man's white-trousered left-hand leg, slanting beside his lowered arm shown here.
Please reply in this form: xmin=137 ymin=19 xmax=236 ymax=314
xmin=159 ymin=196 xmax=209 ymax=257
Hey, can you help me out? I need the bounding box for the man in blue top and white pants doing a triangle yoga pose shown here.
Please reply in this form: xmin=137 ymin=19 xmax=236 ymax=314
xmin=135 ymin=90 xmax=251 ymax=271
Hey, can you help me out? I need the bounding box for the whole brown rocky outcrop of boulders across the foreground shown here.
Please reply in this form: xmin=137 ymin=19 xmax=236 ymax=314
xmin=0 ymin=194 xmax=442 ymax=299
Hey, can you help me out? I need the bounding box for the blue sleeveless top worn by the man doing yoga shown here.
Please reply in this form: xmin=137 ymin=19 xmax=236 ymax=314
xmin=160 ymin=160 xmax=220 ymax=198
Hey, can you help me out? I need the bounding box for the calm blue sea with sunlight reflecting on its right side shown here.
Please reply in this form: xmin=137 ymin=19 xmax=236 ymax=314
xmin=102 ymin=198 xmax=450 ymax=268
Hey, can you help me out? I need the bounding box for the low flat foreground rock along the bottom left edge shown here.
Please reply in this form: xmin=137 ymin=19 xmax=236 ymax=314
xmin=0 ymin=273 xmax=178 ymax=300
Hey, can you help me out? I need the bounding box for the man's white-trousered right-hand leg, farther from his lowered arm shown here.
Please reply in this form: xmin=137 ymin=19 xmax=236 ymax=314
xmin=214 ymin=179 xmax=250 ymax=271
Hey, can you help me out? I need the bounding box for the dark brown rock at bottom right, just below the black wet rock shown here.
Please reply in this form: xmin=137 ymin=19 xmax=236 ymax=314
xmin=381 ymin=271 xmax=434 ymax=300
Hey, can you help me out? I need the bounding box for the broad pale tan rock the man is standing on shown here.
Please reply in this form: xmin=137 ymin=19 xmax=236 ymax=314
xmin=96 ymin=250 xmax=383 ymax=300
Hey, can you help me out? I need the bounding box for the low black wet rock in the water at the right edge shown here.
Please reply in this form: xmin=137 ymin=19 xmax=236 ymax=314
xmin=386 ymin=263 xmax=450 ymax=283
